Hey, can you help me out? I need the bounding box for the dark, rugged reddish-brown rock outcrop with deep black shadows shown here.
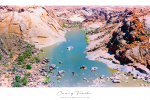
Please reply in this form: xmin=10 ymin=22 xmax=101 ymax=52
xmin=107 ymin=16 xmax=150 ymax=68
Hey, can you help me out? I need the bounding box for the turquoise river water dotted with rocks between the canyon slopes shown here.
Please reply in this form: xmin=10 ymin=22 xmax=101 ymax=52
xmin=41 ymin=30 xmax=113 ymax=87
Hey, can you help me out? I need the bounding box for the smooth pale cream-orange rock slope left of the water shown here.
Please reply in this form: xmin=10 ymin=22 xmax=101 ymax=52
xmin=0 ymin=6 xmax=65 ymax=48
